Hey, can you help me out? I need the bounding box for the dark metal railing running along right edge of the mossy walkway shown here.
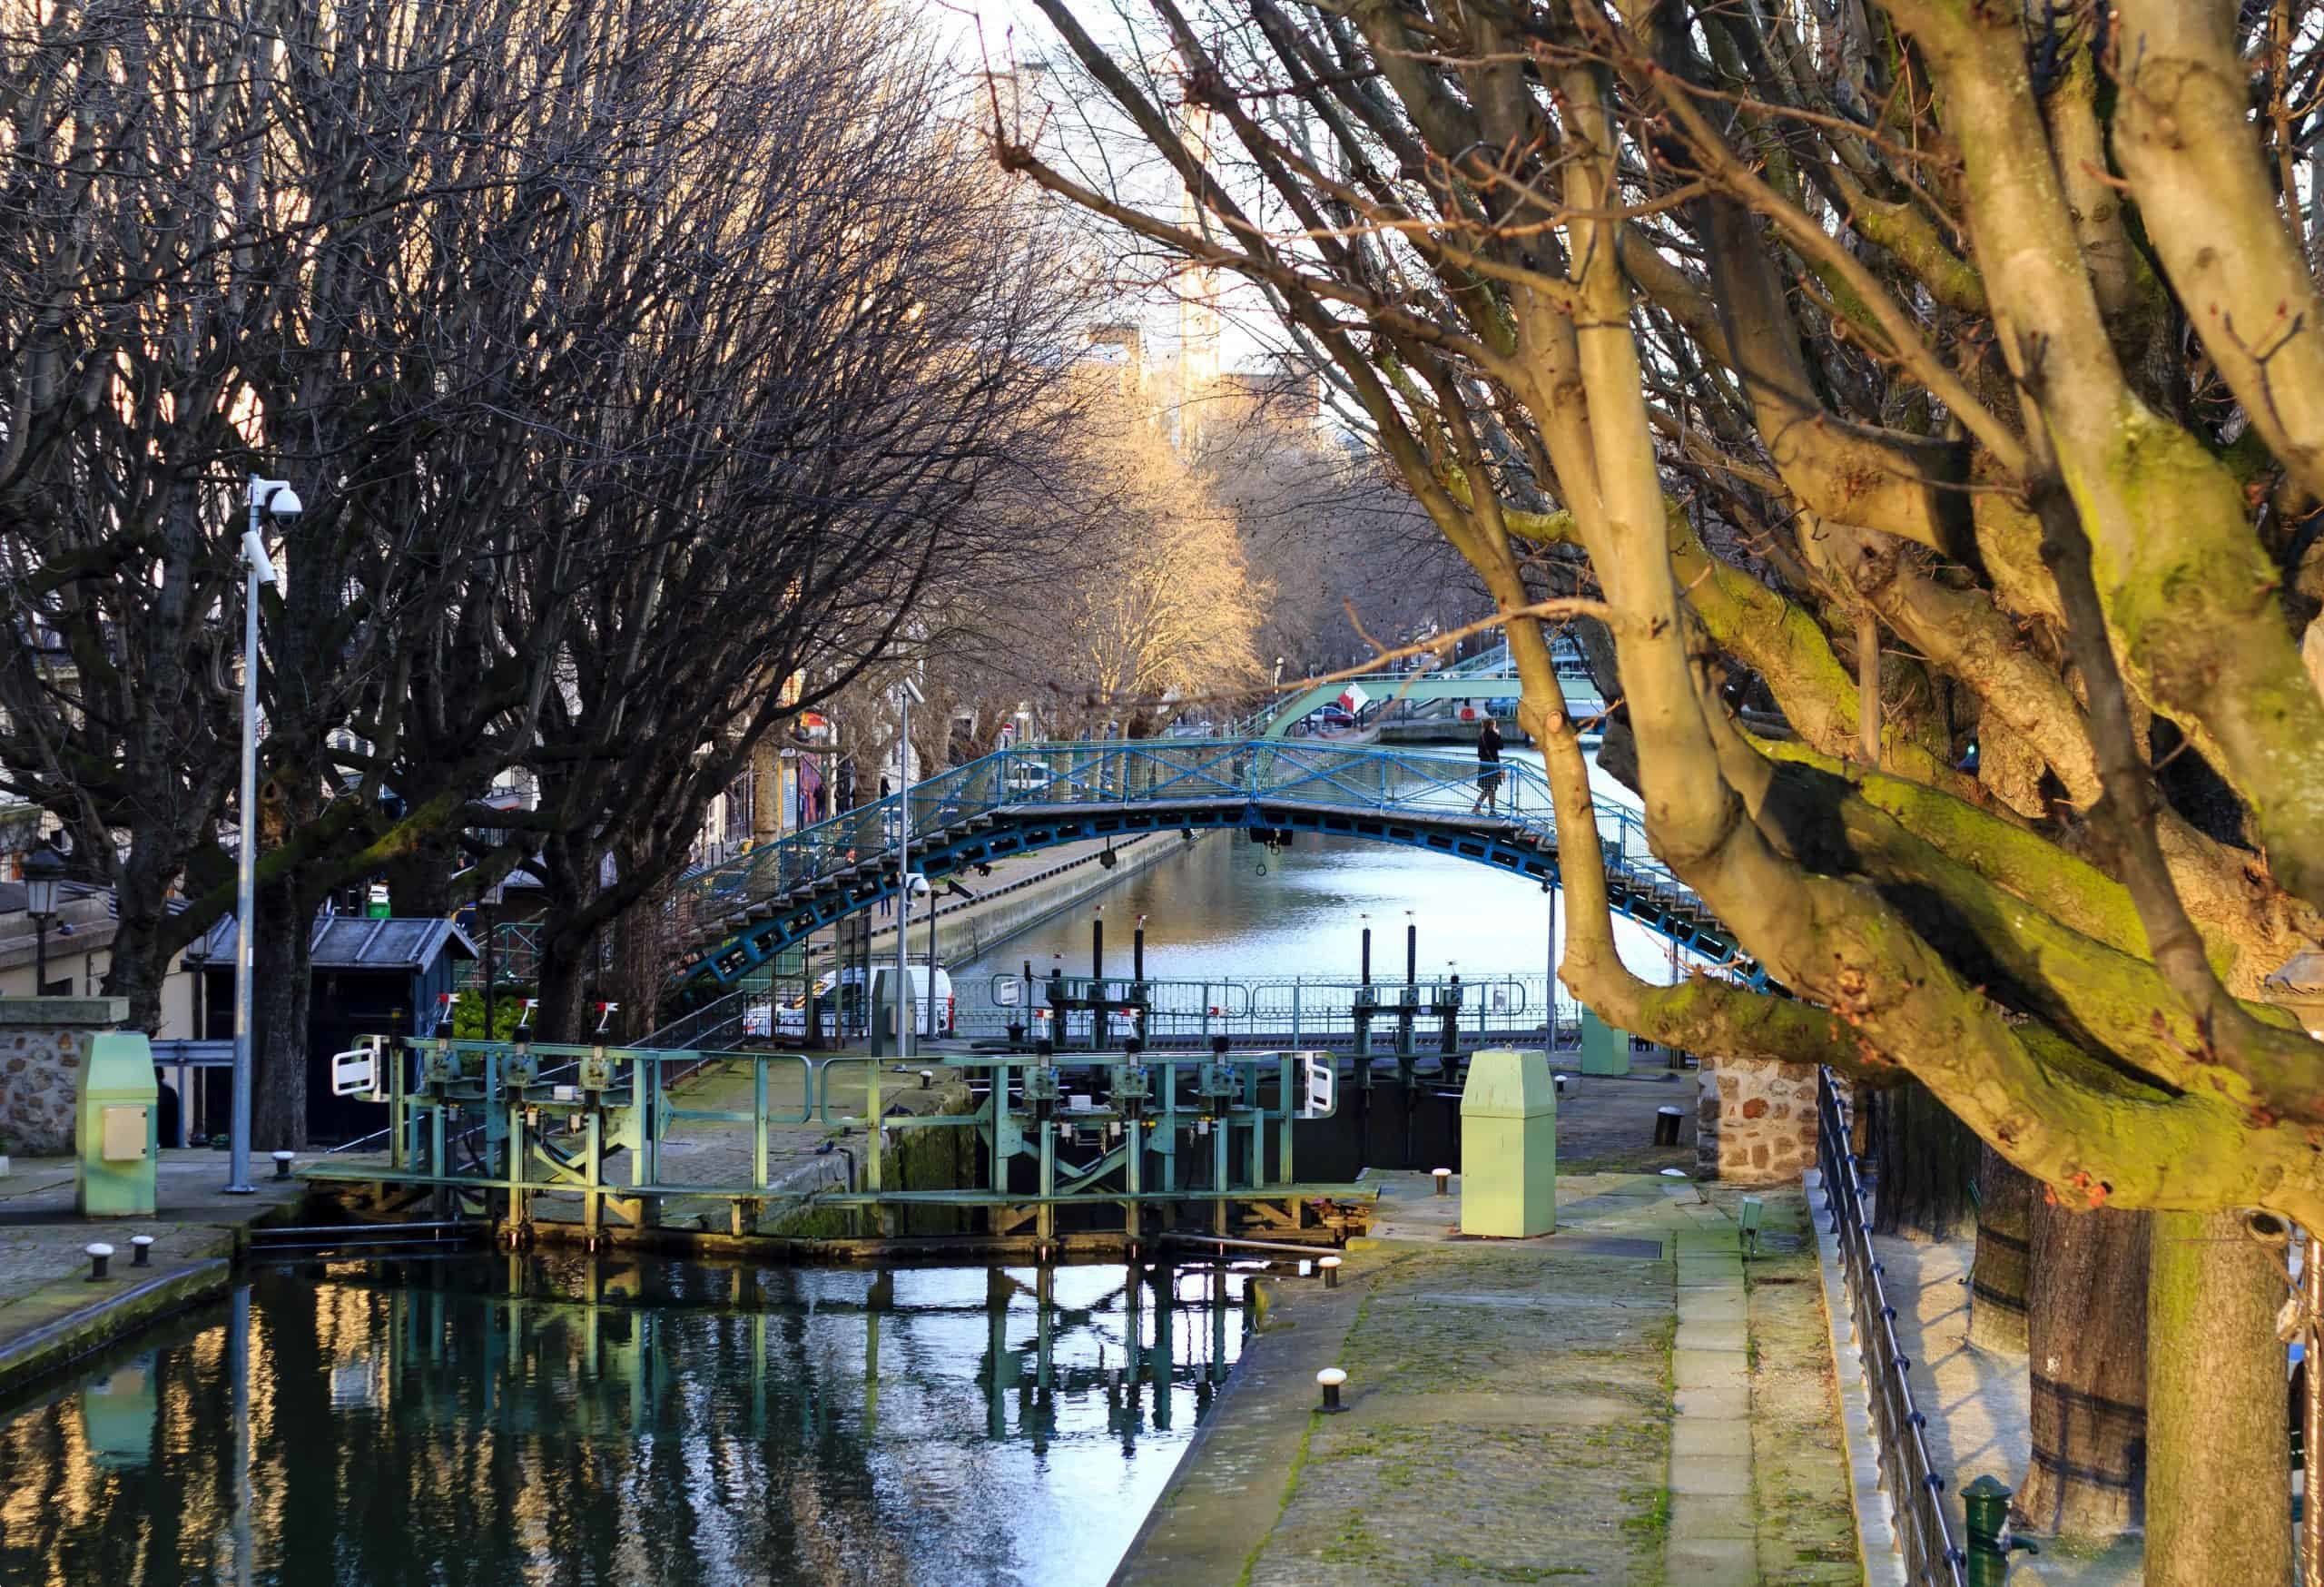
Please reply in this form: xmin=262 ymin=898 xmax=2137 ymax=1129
xmin=1815 ymin=1069 xmax=1966 ymax=1587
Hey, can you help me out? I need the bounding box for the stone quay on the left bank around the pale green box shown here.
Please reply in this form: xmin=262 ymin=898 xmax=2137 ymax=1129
xmin=0 ymin=1150 xmax=304 ymax=1392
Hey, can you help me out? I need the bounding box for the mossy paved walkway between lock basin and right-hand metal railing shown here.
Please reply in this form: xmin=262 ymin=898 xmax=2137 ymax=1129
xmin=1116 ymin=1173 xmax=1862 ymax=1587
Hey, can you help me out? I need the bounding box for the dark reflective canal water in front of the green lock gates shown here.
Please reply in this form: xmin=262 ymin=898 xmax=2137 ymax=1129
xmin=0 ymin=1257 xmax=1246 ymax=1587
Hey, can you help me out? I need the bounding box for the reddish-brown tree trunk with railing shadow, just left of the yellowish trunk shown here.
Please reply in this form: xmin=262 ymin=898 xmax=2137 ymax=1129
xmin=2015 ymin=1197 xmax=2150 ymax=1545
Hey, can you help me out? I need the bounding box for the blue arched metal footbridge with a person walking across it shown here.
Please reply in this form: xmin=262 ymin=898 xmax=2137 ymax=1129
xmin=676 ymin=739 xmax=1759 ymax=985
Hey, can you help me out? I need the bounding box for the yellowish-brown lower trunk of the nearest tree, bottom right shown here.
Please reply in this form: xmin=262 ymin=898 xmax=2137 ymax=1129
xmin=2145 ymin=1213 xmax=2291 ymax=1587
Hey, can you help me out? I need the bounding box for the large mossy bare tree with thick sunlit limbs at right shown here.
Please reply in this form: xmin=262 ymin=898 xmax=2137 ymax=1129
xmin=1022 ymin=0 xmax=2324 ymax=1582
